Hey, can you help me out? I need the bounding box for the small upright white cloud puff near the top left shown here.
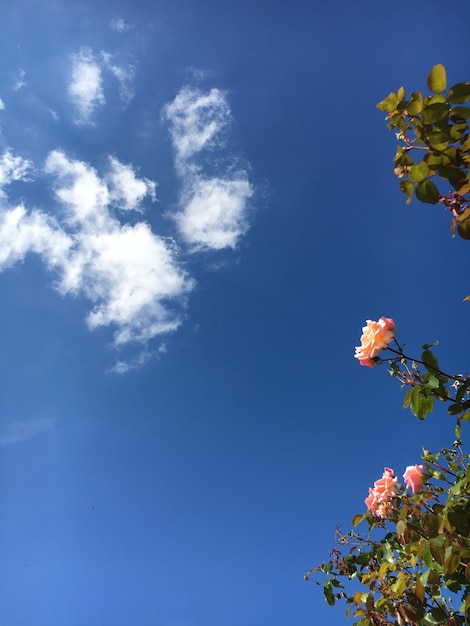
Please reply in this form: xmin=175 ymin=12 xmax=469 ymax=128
xmin=67 ymin=48 xmax=105 ymax=124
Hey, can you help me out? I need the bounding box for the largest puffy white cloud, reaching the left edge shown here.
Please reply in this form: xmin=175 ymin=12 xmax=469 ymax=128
xmin=0 ymin=150 xmax=194 ymax=345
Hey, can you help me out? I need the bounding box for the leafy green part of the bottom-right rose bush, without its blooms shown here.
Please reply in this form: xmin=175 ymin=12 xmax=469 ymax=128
xmin=305 ymin=440 xmax=470 ymax=626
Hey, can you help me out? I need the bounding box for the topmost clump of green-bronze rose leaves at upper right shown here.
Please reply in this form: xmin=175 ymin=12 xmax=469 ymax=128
xmin=377 ymin=65 xmax=470 ymax=239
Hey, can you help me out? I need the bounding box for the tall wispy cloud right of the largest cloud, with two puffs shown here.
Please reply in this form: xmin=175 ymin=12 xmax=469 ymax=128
xmin=163 ymin=87 xmax=253 ymax=252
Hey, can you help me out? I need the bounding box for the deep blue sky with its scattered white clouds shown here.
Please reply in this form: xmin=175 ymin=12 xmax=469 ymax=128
xmin=0 ymin=0 xmax=469 ymax=626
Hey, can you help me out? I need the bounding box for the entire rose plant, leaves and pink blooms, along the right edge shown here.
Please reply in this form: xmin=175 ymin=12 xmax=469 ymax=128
xmin=305 ymin=65 xmax=470 ymax=626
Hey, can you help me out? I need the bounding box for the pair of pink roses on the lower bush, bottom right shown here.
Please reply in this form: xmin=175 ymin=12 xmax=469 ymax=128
xmin=364 ymin=465 xmax=424 ymax=518
